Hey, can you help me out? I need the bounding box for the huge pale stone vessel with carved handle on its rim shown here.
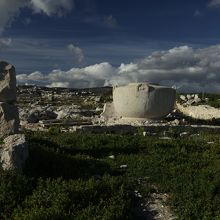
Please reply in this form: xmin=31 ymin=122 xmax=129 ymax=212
xmin=113 ymin=83 xmax=176 ymax=119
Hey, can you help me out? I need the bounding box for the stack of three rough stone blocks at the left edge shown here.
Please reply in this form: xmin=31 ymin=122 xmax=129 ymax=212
xmin=0 ymin=61 xmax=28 ymax=172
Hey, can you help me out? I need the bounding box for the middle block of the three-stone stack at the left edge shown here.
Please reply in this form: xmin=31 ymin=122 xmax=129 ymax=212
xmin=0 ymin=102 xmax=19 ymax=138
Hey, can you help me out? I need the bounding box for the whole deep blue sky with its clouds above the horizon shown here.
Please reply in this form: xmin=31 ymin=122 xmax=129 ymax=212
xmin=0 ymin=0 xmax=220 ymax=93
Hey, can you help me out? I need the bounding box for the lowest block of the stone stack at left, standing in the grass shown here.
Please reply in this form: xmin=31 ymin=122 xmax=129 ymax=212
xmin=0 ymin=134 xmax=29 ymax=173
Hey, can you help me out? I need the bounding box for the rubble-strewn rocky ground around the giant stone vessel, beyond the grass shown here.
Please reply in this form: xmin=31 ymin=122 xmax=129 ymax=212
xmin=17 ymin=86 xmax=220 ymax=131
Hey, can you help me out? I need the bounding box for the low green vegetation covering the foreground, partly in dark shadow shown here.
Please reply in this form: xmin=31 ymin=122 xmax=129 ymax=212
xmin=0 ymin=130 xmax=220 ymax=220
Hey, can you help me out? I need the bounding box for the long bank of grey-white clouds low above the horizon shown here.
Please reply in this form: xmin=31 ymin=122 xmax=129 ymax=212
xmin=17 ymin=45 xmax=220 ymax=92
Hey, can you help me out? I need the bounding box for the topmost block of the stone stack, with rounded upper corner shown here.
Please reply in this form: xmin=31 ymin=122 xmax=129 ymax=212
xmin=0 ymin=61 xmax=16 ymax=102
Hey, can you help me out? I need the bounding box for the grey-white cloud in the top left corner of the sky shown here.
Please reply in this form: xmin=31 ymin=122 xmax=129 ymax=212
xmin=0 ymin=0 xmax=74 ymax=32
